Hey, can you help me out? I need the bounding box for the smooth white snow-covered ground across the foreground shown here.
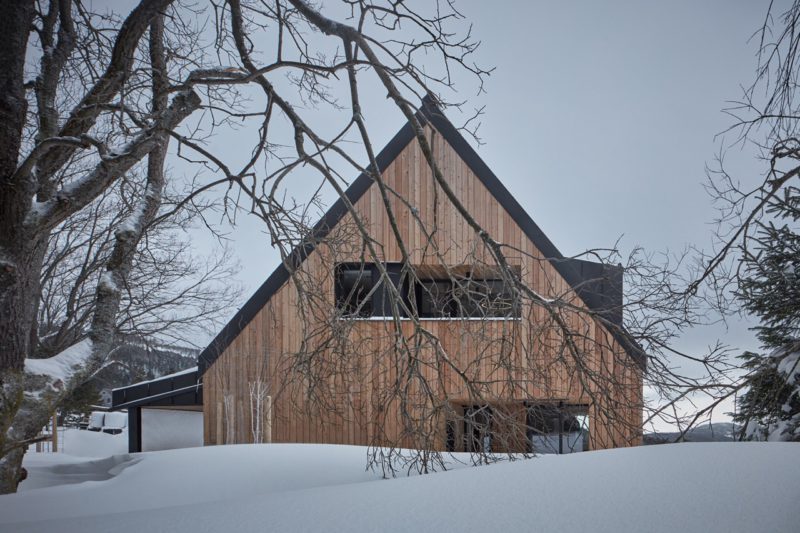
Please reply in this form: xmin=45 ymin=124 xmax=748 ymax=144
xmin=0 ymin=432 xmax=800 ymax=533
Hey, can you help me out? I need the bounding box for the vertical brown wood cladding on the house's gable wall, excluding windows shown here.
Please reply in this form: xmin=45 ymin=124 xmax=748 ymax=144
xmin=203 ymin=126 xmax=642 ymax=449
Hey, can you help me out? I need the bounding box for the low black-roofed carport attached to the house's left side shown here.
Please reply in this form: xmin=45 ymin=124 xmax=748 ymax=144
xmin=111 ymin=367 xmax=203 ymax=452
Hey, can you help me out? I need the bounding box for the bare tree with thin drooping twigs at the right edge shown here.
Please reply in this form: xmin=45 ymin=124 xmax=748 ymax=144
xmin=616 ymin=1 xmax=800 ymax=438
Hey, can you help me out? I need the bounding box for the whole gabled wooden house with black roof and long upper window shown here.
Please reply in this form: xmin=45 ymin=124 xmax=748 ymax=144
xmin=189 ymin=95 xmax=643 ymax=453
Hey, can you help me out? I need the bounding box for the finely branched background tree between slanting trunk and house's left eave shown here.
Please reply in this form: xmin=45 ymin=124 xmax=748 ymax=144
xmin=31 ymin=180 xmax=238 ymax=358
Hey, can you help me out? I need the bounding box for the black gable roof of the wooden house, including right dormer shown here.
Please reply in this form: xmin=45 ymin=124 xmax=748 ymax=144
xmin=197 ymin=96 xmax=644 ymax=376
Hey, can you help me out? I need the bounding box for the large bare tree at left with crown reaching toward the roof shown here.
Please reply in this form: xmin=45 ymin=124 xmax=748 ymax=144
xmin=0 ymin=0 xmax=496 ymax=492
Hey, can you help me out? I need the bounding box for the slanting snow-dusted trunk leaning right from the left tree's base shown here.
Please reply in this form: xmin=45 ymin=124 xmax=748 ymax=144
xmin=0 ymin=11 xmax=183 ymax=494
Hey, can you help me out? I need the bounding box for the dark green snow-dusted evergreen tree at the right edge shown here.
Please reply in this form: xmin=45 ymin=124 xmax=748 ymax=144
xmin=734 ymin=187 xmax=800 ymax=441
